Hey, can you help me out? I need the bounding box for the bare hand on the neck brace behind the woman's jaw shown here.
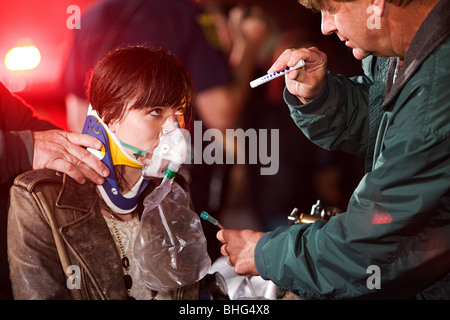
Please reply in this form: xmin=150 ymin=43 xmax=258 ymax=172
xmin=33 ymin=130 xmax=109 ymax=184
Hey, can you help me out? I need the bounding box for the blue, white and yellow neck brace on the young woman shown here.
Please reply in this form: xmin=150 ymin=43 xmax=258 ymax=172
xmin=82 ymin=105 xmax=150 ymax=214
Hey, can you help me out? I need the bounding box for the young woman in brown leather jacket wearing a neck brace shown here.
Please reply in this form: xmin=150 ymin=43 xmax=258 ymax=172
xmin=8 ymin=47 xmax=198 ymax=299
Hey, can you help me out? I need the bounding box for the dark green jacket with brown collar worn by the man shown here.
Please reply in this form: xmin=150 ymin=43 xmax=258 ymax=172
xmin=255 ymin=0 xmax=450 ymax=299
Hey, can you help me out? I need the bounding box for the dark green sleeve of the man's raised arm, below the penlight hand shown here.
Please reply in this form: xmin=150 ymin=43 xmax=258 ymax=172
xmin=284 ymin=73 xmax=370 ymax=156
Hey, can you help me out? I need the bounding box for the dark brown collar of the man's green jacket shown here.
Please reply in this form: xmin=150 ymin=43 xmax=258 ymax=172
xmin=383 ymin=0 xmax=450 ymax=107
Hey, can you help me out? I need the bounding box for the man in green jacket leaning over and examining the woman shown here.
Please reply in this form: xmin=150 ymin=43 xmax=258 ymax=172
xmin=217 ymin=0 xmax=450 ymax=299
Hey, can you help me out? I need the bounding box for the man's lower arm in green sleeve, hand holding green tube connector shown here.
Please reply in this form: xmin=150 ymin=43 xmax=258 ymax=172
xmin=221 ymin=121 xmax=450 ymax=299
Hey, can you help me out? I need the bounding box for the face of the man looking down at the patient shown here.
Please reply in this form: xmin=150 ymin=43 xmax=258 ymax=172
xmin=321 ymin=0 xmax=380 ymax=60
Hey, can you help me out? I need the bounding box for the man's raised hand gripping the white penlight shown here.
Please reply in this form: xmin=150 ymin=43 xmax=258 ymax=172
xmin=268 ymin=47 xmax=327 ymax=103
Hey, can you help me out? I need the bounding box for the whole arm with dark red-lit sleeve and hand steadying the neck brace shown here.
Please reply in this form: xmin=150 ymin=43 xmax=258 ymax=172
xmin=0 ymin=83 xmax=109 ymax=184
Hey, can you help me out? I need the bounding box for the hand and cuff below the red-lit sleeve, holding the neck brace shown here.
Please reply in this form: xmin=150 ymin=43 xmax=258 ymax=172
xmin=0 ymin=130 xmax=108 ymax=184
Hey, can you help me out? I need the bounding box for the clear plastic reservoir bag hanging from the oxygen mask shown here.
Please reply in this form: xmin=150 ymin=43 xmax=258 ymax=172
xmin=133 ymin=179 xmax=211 ymax=292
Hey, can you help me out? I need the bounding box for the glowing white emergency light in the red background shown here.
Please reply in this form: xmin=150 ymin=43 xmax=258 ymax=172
xmin=5 ymin=46 xmax=41 ymax=70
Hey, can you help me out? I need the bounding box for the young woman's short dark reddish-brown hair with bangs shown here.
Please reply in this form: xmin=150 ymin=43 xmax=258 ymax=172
xmin=88 ymin=46 xmax=194 ymax=129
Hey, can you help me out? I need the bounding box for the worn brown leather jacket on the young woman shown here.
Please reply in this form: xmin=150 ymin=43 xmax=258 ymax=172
xmin=8 ymin=170 xmax=198 ymax=300
